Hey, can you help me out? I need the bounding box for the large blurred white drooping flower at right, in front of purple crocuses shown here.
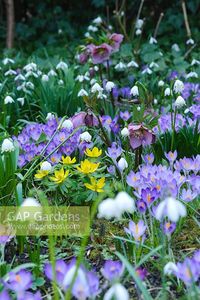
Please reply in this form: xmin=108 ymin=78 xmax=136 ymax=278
xmin=155 ymin=197 xmax=187 ymax=222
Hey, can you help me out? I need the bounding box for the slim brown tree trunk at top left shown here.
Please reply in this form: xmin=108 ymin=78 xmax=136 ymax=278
xmin=5 ymin=0 xmax=15 ymax=48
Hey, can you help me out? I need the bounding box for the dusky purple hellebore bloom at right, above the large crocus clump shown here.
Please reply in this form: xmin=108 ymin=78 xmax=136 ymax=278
xmin=128 ymin=123 xmax=155 ymax=149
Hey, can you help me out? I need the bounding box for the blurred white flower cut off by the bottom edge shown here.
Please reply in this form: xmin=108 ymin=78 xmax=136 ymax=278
xmin=103 ymin=283 xmax=129 ymax=300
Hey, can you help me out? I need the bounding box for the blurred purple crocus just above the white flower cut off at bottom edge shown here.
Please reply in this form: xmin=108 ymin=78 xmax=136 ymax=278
xmin=101 ymin=260 xmax=124 ymax=281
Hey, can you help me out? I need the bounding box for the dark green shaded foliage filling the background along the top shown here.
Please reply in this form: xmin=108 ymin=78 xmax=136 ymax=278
xmin=0 ymin=0 xmax=200 ymax=52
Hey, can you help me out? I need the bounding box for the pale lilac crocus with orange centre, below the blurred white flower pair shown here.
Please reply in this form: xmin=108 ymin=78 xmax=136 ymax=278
xmin=124 ymin=220 xmax=147 ymax=242
